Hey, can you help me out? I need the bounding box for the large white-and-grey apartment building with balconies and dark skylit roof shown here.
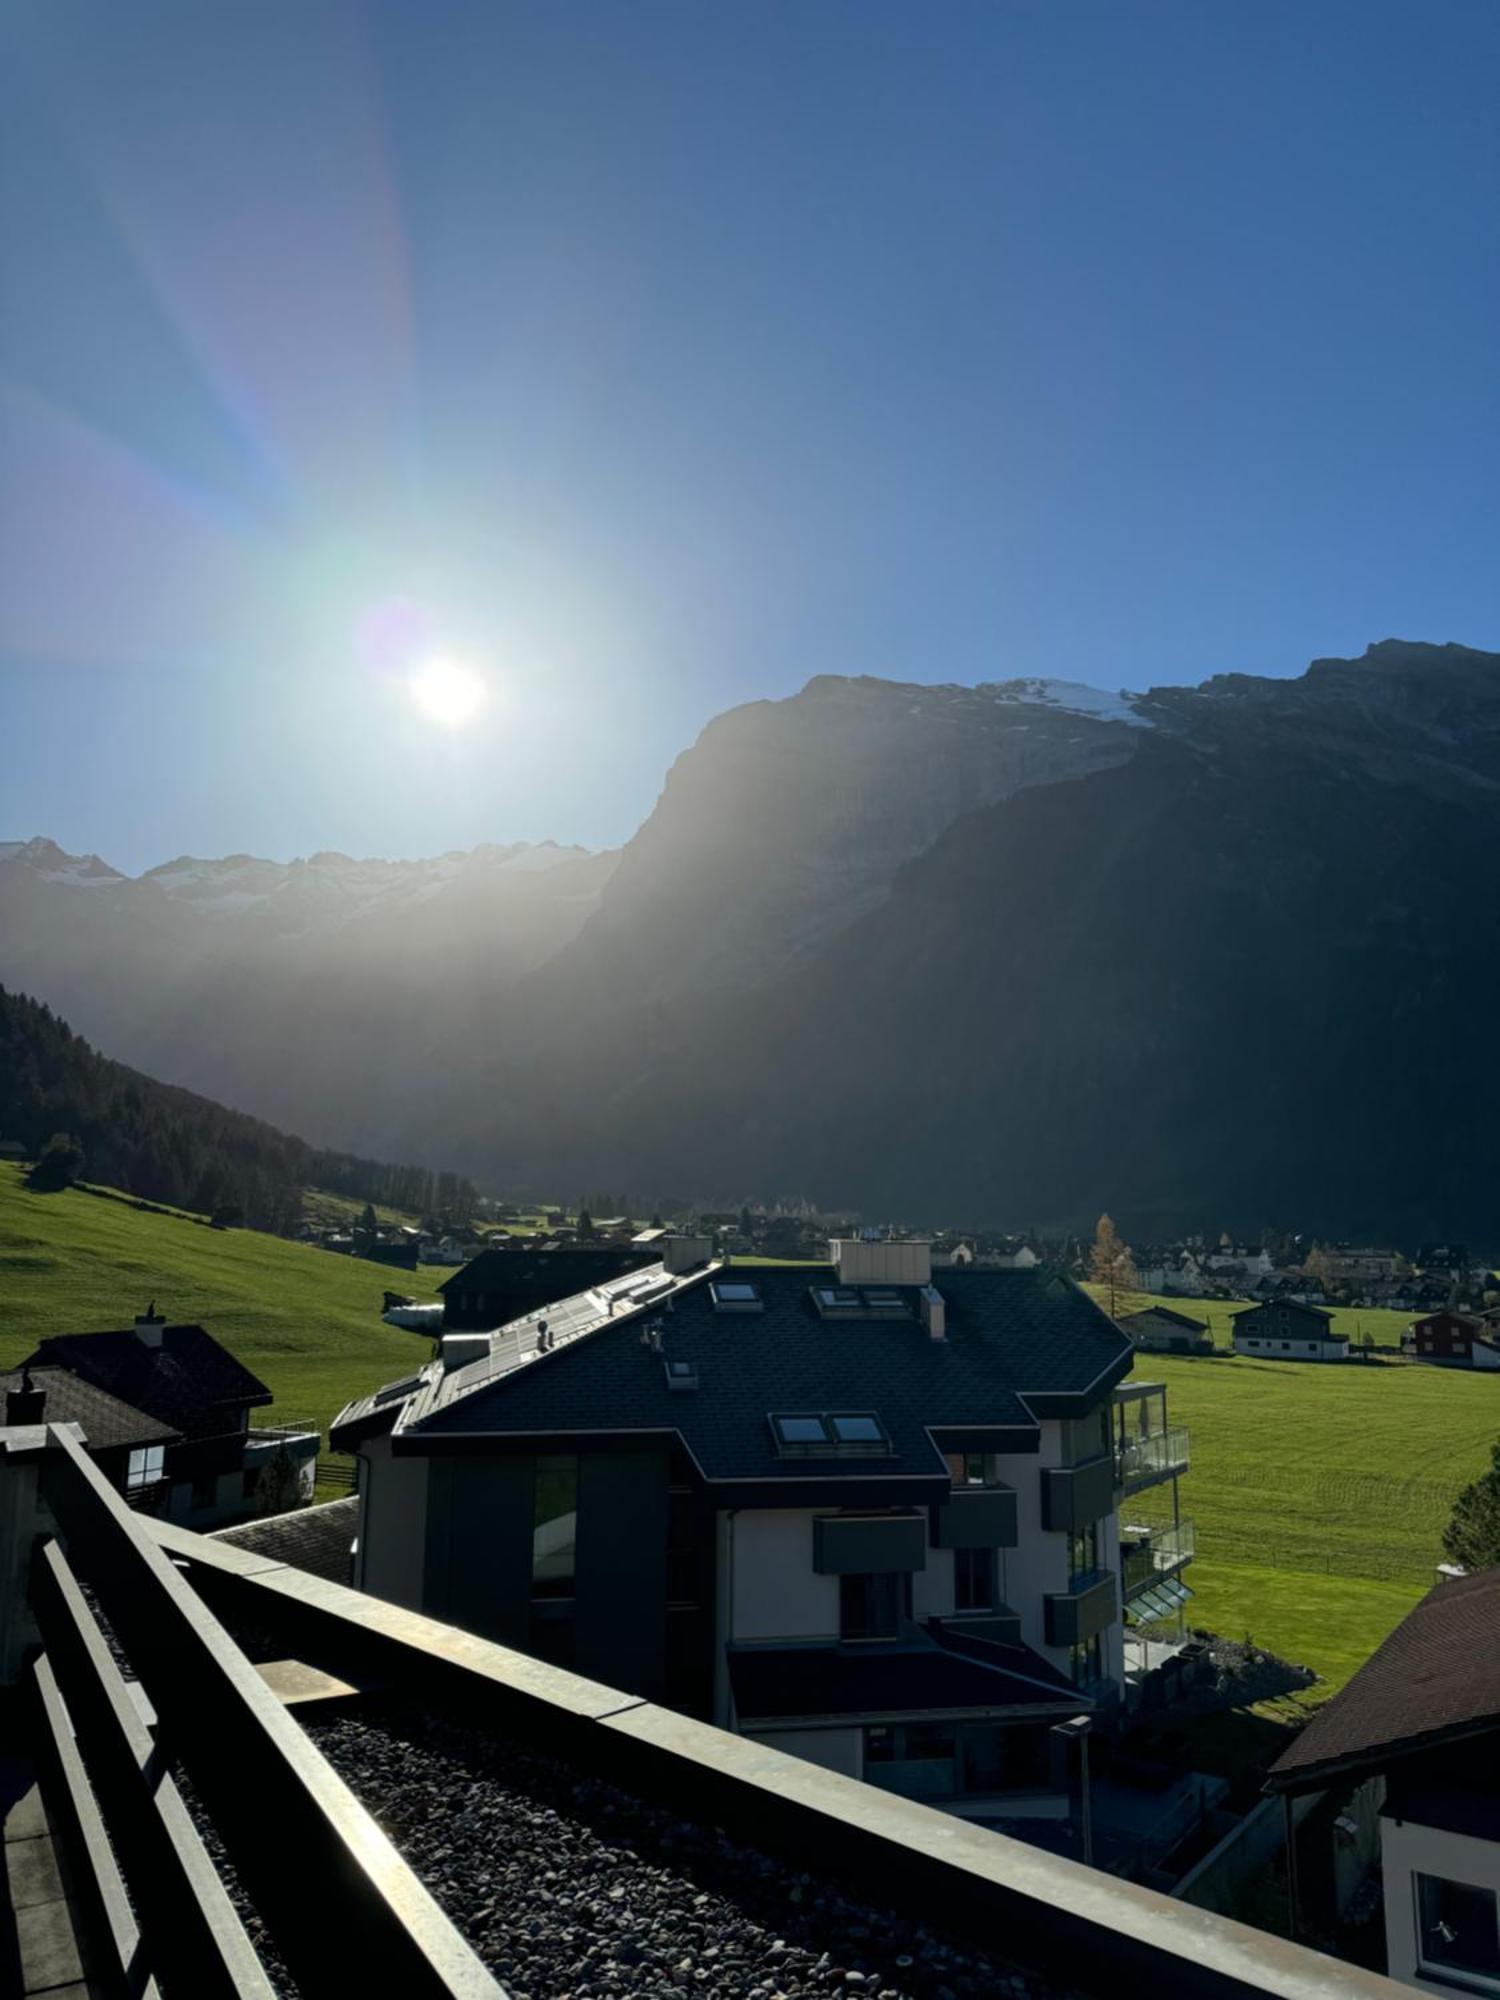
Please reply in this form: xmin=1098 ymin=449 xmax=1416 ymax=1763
xmin=332 ymin=1242 xmax=1190 ymax=1812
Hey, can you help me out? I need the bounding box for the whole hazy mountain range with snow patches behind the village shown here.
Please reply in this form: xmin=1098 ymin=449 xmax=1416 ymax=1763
xmin=0 ymin=640 xmax=1500 ymax=1240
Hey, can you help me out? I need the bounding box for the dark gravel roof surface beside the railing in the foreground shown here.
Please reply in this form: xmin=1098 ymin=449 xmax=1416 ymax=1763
xmin=308 ymin=1706 xmax=1064 ymax=2000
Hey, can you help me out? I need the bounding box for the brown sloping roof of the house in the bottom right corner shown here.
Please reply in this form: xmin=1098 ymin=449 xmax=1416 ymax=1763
xmin=1266 ymin=1568 xmax=1500 ymax=1792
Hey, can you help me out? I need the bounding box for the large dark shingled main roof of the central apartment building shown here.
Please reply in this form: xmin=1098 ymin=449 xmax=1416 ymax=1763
xmin=346 ymin=1266 xmax=1134 ymax=1482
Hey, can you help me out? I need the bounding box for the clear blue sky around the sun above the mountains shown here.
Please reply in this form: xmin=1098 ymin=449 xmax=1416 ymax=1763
xmin=0 ymin=0 xmax=1500 ymax=868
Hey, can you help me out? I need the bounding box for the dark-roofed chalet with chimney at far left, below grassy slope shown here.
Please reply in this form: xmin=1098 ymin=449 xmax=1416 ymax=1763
xmin=22 ymin=1306 xmax=322 ymax=1528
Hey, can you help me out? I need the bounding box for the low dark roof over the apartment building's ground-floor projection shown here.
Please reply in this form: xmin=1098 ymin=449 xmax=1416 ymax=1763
xmin=728 ymin=1640 xmax=1088 ymax=1724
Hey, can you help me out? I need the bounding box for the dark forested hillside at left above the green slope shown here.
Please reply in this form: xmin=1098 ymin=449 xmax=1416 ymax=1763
xmin=0 ymin=986 xmax=476 ymax=1236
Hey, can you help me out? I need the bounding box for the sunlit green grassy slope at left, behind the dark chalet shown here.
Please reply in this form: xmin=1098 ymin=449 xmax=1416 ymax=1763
xmin=0 ymin=1164 xmax=446 ymax=1424
